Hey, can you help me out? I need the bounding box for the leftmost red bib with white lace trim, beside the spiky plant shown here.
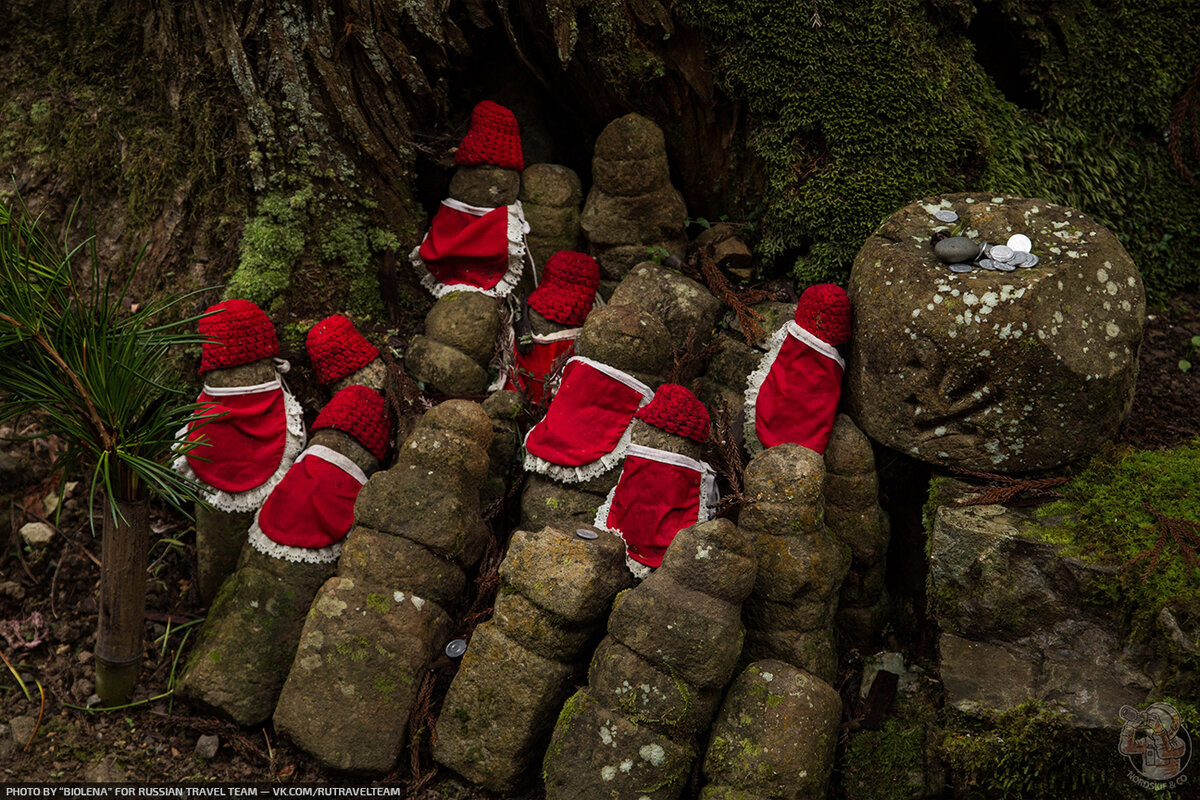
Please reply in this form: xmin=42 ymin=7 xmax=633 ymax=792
xmin=186 ymin=380 xmax=288 ymax=493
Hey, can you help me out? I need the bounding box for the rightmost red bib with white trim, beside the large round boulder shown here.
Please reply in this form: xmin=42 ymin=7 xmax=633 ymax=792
xmin=746 ymin=323 xmax=844 ymax=455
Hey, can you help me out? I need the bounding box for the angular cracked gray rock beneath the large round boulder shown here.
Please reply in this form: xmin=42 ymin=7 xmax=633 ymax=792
xmin=929 ymin=506 xmax=1160 ymax=729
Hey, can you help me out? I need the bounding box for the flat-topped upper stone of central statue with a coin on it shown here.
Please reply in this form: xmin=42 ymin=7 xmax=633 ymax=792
xmin=500 ymin=525 xmax=632 ymax=622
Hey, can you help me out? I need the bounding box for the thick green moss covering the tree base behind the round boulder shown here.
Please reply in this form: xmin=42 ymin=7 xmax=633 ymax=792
xmin=683 ymin=0 xmax=1200 ymax=296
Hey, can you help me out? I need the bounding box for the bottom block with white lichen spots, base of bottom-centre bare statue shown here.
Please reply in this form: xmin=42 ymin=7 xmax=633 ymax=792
xmin=542 ymin=690 xmax=696 ymax=800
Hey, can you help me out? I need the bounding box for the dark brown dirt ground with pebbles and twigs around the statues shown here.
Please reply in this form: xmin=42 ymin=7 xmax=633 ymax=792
xmin=0 ymin=294 xmax=1200 ymax=786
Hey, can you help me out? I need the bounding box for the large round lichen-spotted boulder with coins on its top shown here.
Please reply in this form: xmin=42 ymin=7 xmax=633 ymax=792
xmin=846 ymin=194 xmax=1146 ymax=473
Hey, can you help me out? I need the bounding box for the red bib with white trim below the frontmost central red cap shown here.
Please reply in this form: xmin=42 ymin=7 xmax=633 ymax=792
xmin=595 ymin=445 xmax=713 ymax=569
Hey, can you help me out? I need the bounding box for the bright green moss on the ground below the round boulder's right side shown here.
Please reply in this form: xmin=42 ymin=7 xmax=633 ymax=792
xmin=1028 ymin=439 xmax=1200 ymax=643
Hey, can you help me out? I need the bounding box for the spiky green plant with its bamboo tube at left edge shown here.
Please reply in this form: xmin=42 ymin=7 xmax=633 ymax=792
xmin=0 ymin=196 xmax=208 ymax=703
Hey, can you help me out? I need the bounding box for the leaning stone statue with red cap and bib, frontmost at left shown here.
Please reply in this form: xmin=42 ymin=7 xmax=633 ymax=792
xmin=179 ymin=385 xmax=391 ymax=726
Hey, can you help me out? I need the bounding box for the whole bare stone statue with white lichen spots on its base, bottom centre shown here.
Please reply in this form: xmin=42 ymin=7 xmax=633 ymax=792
xmin=544 ymin=519 xmax=755 ymax=800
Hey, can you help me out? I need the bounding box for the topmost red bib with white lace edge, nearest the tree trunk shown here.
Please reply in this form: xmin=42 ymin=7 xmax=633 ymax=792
xmin=412 ymin=200 xmax=526 ymax=297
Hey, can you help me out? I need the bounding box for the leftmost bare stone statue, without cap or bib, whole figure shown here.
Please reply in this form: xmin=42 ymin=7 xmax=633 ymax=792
xmin=275 ymin=401 xmax=492 ymax=775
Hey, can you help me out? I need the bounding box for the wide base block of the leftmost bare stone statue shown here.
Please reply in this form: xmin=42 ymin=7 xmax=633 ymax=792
xmin=275 ymin=577 xmax=451 ymax=775
